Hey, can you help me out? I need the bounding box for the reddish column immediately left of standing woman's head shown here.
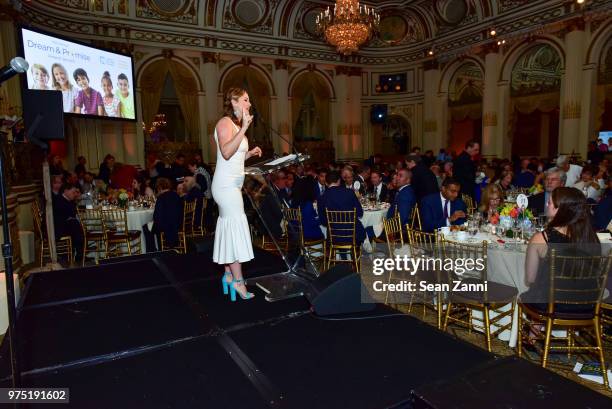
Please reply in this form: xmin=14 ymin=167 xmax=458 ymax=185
xmin=198 ymin=52 xmax=219 ymax=162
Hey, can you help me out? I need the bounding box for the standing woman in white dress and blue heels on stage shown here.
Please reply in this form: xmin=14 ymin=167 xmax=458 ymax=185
xmin=212 ymin=88 xmax=261 ymax=301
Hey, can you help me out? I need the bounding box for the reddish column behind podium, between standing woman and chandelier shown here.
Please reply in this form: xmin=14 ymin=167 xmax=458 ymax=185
xmin=270 ymin=60 xmax=293 ymax=154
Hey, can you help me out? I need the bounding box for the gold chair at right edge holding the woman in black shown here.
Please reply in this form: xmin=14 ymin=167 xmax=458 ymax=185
xmin=517 ymin=249 xmax=612 ymax=388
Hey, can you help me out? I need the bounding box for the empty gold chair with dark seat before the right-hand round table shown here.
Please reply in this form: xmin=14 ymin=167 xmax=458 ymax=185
xmin=440 ymin=239 xmax=518 ymax=352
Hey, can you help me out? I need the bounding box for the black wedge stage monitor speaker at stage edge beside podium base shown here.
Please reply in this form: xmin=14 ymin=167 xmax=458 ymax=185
xmin=311 ymin=264 xmax=376 ymax=315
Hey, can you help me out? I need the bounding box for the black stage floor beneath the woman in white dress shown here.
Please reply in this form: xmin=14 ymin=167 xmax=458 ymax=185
xmin=0 ymin=247 xmax=608 ymax=408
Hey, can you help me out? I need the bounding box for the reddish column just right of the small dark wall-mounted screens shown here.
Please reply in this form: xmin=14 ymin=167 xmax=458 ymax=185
xmin=424 ymin=60 xmax=446 ymax=152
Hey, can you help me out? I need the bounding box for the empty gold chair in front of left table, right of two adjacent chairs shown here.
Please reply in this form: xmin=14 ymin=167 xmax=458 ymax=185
xmin=102 ymin=209 xmax=142 ymax=257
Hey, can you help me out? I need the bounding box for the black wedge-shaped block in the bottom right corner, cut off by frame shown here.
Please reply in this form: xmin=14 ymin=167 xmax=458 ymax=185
xmin=402 ymin=356 xmax=610 ymax=409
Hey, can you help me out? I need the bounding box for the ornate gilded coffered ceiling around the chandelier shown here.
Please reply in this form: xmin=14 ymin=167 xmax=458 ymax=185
xmin=12 ymin=0 xmax=612 ymax=65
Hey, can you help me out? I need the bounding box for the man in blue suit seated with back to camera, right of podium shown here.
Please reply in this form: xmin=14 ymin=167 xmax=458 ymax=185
xmin=317 ymin=170 xmax=366 ymax=244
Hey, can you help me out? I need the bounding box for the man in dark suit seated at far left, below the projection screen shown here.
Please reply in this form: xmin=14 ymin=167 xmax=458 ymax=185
xmin=53 ymin=184 xmax=85 ymax=262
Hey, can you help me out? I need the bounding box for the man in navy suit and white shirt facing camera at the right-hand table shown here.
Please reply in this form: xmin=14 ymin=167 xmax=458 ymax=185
xmin=420 ymin=177 xmax=467 ymax=232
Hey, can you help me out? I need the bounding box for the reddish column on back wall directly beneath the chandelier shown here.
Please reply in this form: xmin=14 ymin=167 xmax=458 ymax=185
xmin=332 ymin=66 xmax=349 ymax=159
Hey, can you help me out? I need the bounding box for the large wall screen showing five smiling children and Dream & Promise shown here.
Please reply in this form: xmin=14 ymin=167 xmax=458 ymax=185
xmin=20 ymin=27 xmax=136 ymax=120
